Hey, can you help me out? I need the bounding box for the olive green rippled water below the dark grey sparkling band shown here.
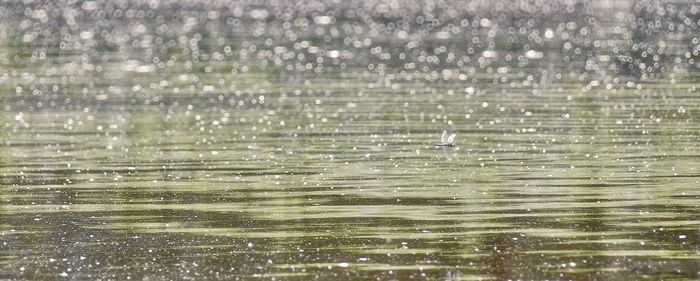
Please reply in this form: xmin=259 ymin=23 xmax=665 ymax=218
xmin=0 ymin=1 xmax=700 ymax=280
